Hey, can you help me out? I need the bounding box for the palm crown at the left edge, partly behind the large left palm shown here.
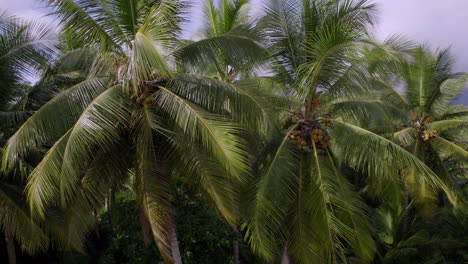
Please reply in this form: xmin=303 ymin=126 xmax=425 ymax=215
xmin=0 ymin=13 xmax=87 ymax=262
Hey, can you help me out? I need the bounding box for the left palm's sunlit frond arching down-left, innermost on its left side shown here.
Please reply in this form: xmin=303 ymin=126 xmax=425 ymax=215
xmin=60 ymin=85 xmax=131 ymax=206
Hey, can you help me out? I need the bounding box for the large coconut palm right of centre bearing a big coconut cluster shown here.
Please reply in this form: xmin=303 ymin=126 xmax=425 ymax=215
xmin=244 ymin=0 xmax=453 ymax=263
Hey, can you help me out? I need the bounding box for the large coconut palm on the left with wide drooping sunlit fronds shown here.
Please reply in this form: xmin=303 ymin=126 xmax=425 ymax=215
xmin=3 ymin=0 xmax=276 ymax=263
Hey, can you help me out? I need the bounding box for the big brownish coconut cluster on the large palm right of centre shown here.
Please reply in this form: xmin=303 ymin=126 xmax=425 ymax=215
xmin=289 ymin=124 xmax=330 ymax=151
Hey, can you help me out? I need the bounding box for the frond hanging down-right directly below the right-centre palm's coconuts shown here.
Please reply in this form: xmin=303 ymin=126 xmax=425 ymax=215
xmin=298 ymin=150 xmax=375 ymax=263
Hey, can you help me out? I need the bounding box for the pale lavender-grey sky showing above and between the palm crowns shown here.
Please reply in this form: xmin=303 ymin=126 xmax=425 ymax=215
xmin=0 ymin=0 xmax=468 ymax=105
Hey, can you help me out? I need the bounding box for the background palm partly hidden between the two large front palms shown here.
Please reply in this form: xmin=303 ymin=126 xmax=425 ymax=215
xmin=176 ymin=0 xmax=276 ymax=263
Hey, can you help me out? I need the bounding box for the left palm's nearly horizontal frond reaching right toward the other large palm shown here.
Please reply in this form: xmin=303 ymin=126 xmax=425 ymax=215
xmin=168 ymin=74 xmax=286 ymax=135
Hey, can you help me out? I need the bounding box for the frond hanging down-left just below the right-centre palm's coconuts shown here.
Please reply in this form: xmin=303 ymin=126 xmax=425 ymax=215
xmin=241 ymin=128 xmax=300 ymax=259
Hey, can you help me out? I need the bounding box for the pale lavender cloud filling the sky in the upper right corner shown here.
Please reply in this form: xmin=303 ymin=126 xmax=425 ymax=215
xmin=377 ymin=0 xmax=468 ymax=71
